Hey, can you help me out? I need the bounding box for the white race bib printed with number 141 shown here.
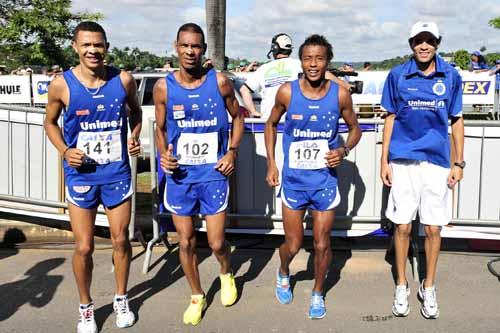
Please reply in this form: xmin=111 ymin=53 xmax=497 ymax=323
xmin=76 ymin=130 xmax=122 ymax=164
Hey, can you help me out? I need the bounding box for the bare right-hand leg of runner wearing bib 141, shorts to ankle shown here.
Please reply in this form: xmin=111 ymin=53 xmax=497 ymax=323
xmin=106 ymin=199 xmax=132 ymax=295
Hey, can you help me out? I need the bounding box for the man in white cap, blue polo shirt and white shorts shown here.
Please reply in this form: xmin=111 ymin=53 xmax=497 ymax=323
xmin=380 ymin=22 xmax=465 ymax=319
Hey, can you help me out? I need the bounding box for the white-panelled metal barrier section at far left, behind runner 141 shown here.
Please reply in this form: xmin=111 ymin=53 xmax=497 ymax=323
xmin=0 ymin=104 xmax=137 ymax=238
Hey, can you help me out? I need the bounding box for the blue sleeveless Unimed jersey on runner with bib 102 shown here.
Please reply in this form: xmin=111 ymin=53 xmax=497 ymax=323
xmin=166 ymin=70 xmax=229 ymax=184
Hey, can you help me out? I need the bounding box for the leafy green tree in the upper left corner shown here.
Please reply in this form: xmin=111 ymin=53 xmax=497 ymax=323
xmin=0 ymin=0 xmax=102 ymax=67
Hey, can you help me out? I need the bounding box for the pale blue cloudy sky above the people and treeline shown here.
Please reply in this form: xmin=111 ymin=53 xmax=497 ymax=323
xmin=73 ymin=0 xmax=500 ymax=61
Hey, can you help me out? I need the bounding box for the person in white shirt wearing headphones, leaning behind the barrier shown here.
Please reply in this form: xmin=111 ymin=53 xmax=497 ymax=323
xmin=240 ymin=33 xmax=302 ymax=119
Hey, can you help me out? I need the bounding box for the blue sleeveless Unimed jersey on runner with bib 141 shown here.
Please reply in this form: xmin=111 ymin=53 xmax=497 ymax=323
xmin=63 ymin=67 xmax=130 ymax=185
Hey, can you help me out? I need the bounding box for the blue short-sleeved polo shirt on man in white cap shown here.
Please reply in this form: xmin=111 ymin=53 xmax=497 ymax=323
xmin=381 ymin=55 xmax=462 ymax=168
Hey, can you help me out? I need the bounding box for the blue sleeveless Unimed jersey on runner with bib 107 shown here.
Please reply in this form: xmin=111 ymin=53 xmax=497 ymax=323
xmin=283 ymin=80 xmax=340 ymax=191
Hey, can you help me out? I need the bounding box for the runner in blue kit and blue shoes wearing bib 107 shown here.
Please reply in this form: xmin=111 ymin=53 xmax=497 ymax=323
xmin=265 ymin=35 xmax=361 ymax=319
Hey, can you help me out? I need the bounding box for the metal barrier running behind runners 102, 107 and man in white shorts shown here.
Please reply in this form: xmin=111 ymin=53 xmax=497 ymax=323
xmin=143 ymin=119 xmax=500 ymax=273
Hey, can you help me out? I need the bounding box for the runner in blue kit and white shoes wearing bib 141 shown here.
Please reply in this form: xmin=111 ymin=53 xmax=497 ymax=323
xmin=44 ymin=22 xmax=142 ymax=333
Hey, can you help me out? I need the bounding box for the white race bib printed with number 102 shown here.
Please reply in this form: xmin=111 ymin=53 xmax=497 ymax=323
xmin=177 ymin=132 xmax=219 ymax=165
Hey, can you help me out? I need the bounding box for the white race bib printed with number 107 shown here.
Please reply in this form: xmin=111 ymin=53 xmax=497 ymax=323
xmin=288 ymin=140 xmax=330 ymax=170
